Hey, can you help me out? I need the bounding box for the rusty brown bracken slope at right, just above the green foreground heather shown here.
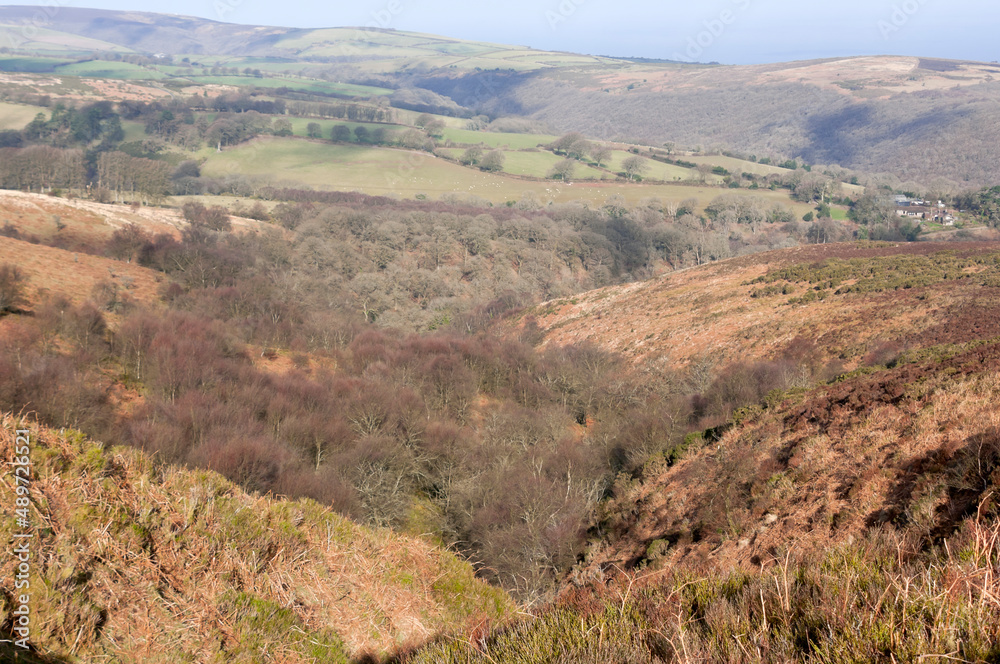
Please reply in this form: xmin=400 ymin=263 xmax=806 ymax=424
xmin=589 ymin=338 xmax=1000 ymax=570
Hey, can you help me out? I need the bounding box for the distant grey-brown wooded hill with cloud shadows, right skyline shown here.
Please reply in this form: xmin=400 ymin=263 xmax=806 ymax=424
xmin=420 ymin=57 xmax=1000 ymax=187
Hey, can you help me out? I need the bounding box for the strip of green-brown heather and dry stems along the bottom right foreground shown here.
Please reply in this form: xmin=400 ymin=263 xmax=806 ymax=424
xmin=409 ymin=519 xmax=1000 ymax=664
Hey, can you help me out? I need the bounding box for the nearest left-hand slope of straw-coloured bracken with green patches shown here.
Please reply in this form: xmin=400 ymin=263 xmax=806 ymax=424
xmin=0 ymin=416 xmax=512 ymax=662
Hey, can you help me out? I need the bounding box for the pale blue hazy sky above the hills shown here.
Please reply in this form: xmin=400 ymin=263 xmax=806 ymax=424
xmin=35 ymin=0 xmax=1000 ymax=63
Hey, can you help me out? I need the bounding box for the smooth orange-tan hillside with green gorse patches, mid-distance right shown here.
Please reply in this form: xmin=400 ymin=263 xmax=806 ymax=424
xmin=531 ymin=242 xmax=1000 ymax=369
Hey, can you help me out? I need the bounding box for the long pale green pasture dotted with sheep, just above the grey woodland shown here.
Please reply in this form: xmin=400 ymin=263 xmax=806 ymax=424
xmin=193 ymin=137 xmax=811 ymax=209
